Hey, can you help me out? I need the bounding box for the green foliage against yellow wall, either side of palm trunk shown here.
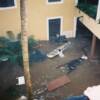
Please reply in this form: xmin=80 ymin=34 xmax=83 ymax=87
xmin=0 ymin=32 xmax=37 ymax=66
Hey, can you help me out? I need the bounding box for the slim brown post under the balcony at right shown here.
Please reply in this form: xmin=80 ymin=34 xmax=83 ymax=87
xmin=90 ymin=34 xmax=97 ymax=60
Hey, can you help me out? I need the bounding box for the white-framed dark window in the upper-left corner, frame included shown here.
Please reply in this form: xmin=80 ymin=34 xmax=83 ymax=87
xmin=0 ymin=0 xmax=16 ymax=9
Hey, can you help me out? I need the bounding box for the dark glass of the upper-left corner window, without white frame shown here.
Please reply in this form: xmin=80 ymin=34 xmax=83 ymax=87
xmin=0 ymin=0 xmax=15 ymax=7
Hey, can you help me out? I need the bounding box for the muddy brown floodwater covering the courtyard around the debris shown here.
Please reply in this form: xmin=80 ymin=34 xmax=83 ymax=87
xmin=0 ymin=39 xmax=100 ymax=100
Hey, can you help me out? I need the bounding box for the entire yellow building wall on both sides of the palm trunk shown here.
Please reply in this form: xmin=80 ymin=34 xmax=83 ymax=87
xmin=0 ymin=0 xmax=75 ymax=40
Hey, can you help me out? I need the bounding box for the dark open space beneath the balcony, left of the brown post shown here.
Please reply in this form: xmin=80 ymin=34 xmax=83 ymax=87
xmin=76 ymin=19 xmax=93 ymax=56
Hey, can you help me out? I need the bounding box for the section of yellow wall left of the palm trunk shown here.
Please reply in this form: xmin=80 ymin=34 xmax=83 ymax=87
xmin=0 ymin=0 xmax=20 ymax=36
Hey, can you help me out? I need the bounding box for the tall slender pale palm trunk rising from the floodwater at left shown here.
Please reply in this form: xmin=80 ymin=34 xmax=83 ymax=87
xmin=20 ymin=0 xmax=32 ymax=100
